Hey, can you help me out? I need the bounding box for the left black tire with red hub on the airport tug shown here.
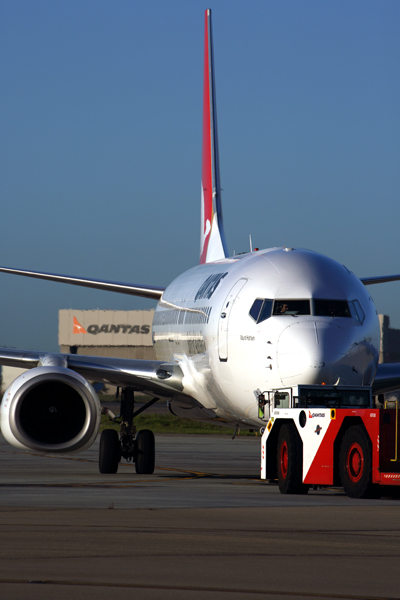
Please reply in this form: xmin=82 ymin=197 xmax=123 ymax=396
xmin=277 ymin=423 xmax=309 ymax=494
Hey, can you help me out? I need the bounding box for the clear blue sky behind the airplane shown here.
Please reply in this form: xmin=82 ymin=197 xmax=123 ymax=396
xmin=0 ymin=0 xmax=400 ymax=350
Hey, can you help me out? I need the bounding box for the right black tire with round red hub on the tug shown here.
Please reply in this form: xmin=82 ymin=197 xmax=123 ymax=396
xmin=339 ymin=425 xmax=380 ymax=498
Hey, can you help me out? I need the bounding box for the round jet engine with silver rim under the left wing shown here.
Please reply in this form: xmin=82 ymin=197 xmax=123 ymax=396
xmin=0 ymin=366 xmax=101 ymax=453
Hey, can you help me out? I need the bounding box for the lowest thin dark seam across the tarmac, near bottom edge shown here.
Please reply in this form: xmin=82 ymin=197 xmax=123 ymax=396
xmin=0 ymin=579 xmax=400 ymax=600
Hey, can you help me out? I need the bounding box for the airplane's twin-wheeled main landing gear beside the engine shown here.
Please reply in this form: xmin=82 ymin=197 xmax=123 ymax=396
xmin=99 ymin=388 xmax=159 ymax=475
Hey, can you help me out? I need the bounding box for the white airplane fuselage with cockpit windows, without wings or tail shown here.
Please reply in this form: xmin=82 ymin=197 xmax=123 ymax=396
xmin=153 ymin=248 xmax=379 ymax=426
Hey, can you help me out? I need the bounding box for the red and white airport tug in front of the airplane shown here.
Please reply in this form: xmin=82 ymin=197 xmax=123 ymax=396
xmin=259 ymin=385 xmax=400 ymax=498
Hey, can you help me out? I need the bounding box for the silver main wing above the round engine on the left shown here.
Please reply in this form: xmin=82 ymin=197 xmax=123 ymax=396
xmin=0 ymin=348 xmax=183 ymax=398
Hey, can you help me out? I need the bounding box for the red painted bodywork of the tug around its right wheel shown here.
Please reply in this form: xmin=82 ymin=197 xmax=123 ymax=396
xmin=304 ymin=409 xmax=381 ymax=485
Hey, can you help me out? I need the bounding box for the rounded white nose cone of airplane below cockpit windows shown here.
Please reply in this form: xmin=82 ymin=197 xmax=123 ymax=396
xmin=277 ymin=320 xmax=354 ymax=386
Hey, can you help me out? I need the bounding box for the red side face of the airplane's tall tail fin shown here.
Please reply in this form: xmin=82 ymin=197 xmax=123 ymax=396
xmin=200 ymin=9 xmax=214 ymax=264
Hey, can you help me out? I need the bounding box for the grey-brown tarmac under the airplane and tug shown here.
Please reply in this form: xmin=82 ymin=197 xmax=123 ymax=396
xmin=0 ymin=434 xmax=400 ymax=600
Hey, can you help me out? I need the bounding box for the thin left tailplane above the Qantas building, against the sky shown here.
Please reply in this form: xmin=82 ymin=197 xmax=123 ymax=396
xmin=0 ymin=267 xmax=165 ymax=300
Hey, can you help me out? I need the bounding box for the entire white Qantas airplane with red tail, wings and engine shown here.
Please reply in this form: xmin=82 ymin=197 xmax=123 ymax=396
xmin=0 ymin=9 xmax=400 ymax=474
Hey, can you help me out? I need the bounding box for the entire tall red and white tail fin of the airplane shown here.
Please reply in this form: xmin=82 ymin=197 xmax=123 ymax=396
xmin=200 ymin=9 xmax=228 ymax=264
